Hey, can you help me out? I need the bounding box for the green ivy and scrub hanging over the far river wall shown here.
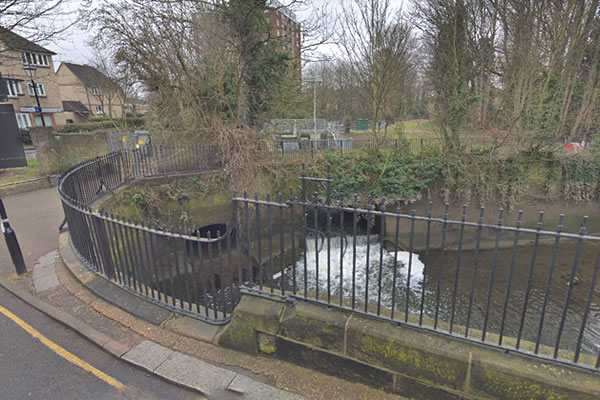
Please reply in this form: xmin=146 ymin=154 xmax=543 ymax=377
xmin=318 ymin=140 xmax=600 ymax=208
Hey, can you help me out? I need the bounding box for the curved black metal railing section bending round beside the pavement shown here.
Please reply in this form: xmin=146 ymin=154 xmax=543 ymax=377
xmin=58 ymin=147 xmax=239 ymax=324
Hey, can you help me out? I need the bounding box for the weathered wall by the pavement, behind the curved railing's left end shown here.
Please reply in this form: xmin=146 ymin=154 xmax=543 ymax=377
xmin=30 ymin=128 xmax=108 ymax=175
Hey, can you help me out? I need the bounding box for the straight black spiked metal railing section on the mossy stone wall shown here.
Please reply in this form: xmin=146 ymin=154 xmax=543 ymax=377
xmin=233 ymin=164 xmax=600 ymax=369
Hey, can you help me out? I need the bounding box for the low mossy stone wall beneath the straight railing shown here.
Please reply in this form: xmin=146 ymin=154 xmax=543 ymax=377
xmin=219 ymin=293 xmax=600 ymax=400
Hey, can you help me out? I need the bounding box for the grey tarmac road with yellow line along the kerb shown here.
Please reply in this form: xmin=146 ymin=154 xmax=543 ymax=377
xmin=0 ymin=287 xmax=202 ymax=400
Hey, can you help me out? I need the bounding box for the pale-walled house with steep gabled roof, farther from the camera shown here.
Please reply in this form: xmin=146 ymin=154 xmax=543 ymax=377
xmin=56 ymin=62 xmax=124 ymax=122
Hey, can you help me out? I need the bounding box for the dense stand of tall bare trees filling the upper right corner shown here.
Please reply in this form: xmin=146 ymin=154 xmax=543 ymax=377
xmin=415 ymin=0 xmax=600 ymax=148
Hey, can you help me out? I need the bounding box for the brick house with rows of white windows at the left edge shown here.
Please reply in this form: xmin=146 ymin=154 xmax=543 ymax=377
xmin=0 ymin=28 xmax=62 ymax=129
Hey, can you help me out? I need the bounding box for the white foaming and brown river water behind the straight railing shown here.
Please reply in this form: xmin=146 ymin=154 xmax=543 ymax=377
xmin=286 ymin=235 xmax=600 ymax=355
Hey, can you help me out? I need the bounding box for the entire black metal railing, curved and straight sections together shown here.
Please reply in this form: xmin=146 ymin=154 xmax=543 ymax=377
xmin=58 ymin=147 xmax=600 ymax=370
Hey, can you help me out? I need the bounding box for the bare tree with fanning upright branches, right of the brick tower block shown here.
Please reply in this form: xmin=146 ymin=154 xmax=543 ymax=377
xmin=337 ymin=0 xmax=413 ymax=141
